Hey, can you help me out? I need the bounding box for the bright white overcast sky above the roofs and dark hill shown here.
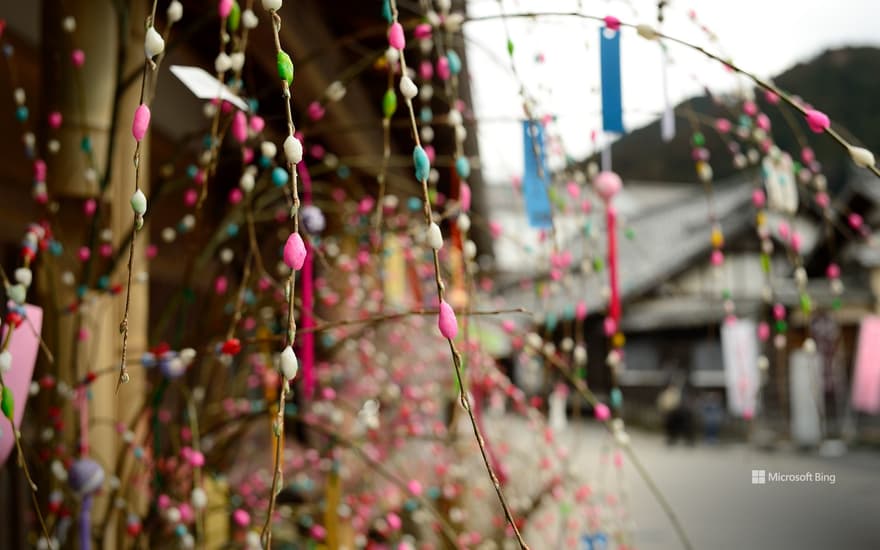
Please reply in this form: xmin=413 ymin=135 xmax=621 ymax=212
xmin=465 ymin=0 xmax=880 ymax=187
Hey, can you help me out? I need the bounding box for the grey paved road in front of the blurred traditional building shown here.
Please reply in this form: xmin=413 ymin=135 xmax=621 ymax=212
xmin=567 ymin=425 xmax=880 ymax=550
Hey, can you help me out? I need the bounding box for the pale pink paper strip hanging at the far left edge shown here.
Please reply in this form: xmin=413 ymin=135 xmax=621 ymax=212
xmin=0 ymin=305 xmax=43 ymax=466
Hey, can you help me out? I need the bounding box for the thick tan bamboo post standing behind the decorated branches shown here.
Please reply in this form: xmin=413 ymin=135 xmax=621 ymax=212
xmin=39 ymin=0 xmax=153 ymax=548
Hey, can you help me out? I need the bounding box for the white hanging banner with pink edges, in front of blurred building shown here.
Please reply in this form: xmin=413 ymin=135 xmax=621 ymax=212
xmin=721 ymin=319 xmax=759 ymax=418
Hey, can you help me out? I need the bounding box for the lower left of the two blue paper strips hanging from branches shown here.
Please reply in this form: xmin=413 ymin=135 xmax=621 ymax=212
xmin=522 ymin=120 xmax=553 ymax=229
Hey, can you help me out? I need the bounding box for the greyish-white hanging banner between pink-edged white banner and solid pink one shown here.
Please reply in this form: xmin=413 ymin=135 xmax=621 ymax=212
xmin=788 ymin=350 xmax=824 ymax=445
